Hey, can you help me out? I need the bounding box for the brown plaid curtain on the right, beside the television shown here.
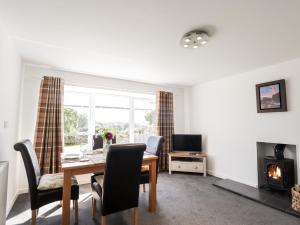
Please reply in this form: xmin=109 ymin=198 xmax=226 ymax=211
xmin=156 ymin=91 xmax=174 ymax=170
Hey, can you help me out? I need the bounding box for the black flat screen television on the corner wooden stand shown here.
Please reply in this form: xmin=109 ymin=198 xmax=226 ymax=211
xmin=172 ymin=134 xmax=202 ymax=152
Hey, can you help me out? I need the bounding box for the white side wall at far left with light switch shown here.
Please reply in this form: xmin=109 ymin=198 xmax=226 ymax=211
xmin=0 ymin=23 xmax=21 ymax=212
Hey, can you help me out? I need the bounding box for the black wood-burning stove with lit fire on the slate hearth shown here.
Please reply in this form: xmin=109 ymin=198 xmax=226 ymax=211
xmin=264 ymin=156 xmax=295 ymax=191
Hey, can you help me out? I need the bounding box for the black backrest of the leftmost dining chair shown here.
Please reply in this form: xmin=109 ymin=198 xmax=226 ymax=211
xmin=14 ymin=140 xmax=41 ymax=202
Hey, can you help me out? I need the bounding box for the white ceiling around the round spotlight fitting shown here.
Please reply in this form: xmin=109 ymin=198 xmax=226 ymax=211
xmin=0 ymin=0 xmax=300 ymax=85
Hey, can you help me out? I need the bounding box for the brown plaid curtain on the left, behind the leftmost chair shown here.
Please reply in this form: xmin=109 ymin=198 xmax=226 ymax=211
xmin=34 ymin=76 xmax=64 ymax=174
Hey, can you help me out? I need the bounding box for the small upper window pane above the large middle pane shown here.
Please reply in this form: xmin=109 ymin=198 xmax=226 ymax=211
xmin=95 ymin=95 xmax=129 ymax=108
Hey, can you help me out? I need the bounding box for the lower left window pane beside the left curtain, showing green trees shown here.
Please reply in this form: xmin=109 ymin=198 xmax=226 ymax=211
xmin=64 ymin=106 xmax=89 ymax=153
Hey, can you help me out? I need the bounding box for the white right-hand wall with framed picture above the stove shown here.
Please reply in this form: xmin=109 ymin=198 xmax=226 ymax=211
xmin=190 ymin=59 xmax=300 ymax=186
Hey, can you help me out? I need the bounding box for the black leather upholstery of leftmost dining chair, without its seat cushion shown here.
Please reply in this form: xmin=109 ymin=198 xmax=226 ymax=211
xmin=14 ymin=140 xmax=79 ymax=210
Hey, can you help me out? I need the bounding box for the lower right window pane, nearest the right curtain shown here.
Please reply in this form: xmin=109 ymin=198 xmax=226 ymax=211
xmin=134 ymin=110 xmax=155 ymax=143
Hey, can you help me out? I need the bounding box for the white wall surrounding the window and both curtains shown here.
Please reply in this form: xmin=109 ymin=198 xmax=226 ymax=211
xmin=19 ymin=65 xmax=185 ymax=190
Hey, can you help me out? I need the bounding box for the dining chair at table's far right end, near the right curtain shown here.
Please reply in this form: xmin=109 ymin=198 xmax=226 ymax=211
xmin=140 ymin=136 xmax=164 ymax=192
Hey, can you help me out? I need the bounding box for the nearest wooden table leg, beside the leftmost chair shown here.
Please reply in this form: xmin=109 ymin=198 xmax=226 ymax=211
xmin=62 ymin=170 xmax=72 ymax=225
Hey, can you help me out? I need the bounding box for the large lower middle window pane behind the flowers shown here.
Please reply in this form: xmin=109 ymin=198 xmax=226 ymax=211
xmin=95 ymin=107 xmax=129 ymax=143
